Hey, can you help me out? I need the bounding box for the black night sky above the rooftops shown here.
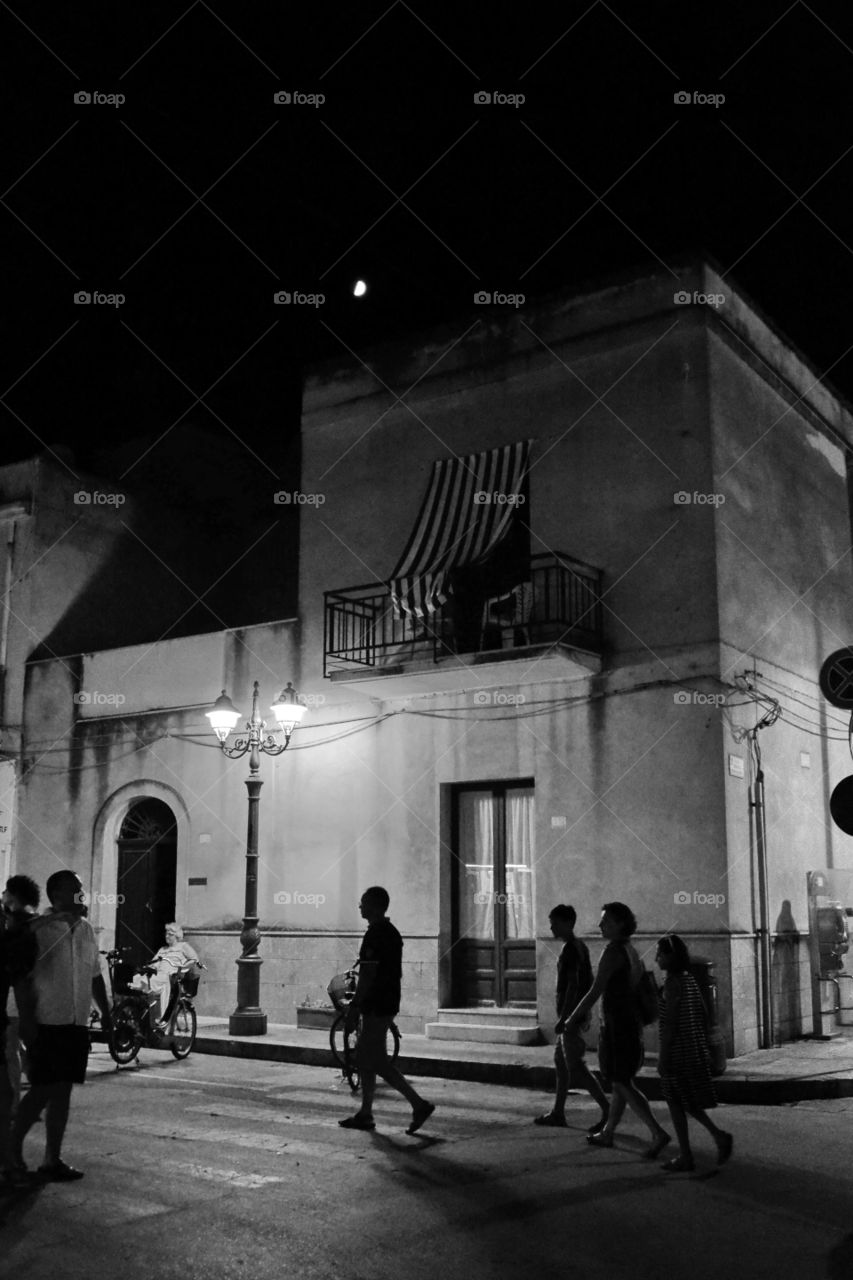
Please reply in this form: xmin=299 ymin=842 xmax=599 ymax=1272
xmin=0 ymin=0 xmax=853 ymax=483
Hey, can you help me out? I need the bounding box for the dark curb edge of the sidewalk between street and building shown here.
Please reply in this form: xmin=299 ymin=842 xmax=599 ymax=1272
xmin=195 ymin=1034 xmax=853 ymax=1107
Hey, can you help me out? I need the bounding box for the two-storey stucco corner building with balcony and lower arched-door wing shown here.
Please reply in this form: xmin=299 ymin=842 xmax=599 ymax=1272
xmin=10 ymin=264 xmax=853 ymax=1052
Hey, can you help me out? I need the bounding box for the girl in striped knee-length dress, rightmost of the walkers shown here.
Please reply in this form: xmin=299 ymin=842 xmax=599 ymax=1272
xmin=656 ymin=933 xmax=733 ymax=1174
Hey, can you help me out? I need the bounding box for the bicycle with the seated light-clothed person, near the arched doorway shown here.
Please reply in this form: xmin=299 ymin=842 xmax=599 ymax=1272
xmin=101 ymin=948 xmax=205 ymax=1066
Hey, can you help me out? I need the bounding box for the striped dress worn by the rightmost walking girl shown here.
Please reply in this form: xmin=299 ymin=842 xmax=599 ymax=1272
xmin=660 ymin=973 xmax=717 ymax=1111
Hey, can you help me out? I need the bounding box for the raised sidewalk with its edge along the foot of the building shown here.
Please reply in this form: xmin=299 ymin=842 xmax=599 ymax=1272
xmin=195 ymin=1018 xmax=853 ymax=1106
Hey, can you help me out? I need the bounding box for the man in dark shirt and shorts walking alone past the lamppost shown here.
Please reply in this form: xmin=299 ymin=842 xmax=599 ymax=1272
xmin=338 ymin=884 xmax=435 ymax=1133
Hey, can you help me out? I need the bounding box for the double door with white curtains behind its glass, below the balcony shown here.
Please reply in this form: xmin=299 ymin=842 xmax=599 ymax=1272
xmin=451 ymin=783 xmax=537 ymax=1009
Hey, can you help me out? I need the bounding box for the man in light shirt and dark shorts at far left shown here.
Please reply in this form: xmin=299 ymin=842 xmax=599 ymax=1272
xmin=12 ymin=870 xmax=111 ymax=1183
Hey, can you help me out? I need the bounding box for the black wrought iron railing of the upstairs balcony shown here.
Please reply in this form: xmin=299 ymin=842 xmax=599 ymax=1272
xmin=323 ymin=553 xmax=602 ymax=676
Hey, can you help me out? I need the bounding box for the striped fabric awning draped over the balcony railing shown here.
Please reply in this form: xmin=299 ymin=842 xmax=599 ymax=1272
xmin=388 ymin=440 xmax=530 ymax=618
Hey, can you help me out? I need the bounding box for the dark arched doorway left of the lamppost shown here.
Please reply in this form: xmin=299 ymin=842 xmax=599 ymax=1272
xmin=115 ymin=799 xmax=178 ymax=964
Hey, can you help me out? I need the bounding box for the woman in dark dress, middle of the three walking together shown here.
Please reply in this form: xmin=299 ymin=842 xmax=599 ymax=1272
xmin=566 ymin=902 xmax=671 ymax=1160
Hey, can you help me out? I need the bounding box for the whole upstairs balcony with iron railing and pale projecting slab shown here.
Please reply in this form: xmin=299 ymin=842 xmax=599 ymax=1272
xmin=323 ymin=553 xmax=602 ymax=698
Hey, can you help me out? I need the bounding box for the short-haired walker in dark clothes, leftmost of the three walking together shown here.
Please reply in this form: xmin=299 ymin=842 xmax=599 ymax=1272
xmin=533 ymin=902 xmax=610 ymax=1134
